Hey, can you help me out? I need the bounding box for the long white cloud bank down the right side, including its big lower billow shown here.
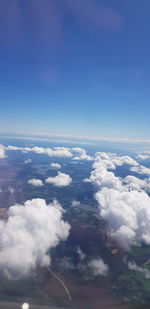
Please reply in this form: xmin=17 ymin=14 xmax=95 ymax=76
xmin=89 ymin=153 xmax=150 ymax=249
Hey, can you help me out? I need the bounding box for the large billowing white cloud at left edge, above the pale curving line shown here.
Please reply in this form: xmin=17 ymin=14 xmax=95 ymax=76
xmin=0 ymin=199 xmax=70 ymax=279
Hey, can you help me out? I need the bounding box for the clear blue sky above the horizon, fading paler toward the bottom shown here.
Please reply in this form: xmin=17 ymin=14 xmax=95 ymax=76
xmin=0 ymin=0 xmax=150 ymax=138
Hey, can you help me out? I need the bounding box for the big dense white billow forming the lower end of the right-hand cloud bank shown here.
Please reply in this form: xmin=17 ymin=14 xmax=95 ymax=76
xmin=96 ymin=188 xmax=150 ymax=249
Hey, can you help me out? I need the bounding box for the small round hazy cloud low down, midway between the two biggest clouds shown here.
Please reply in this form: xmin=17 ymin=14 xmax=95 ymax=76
xmin=88 ymin=258 xmax=109 ymax=277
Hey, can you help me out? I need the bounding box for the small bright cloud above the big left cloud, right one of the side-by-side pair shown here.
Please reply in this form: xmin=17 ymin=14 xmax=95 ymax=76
xmin=46 ymin=172 xmax=72 ymax=187
